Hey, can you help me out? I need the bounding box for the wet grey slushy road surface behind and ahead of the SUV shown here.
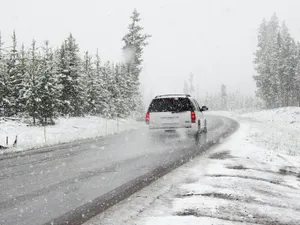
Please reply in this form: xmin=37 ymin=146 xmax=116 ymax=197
xmin=0 ymin=116 xmax=238 ymax=225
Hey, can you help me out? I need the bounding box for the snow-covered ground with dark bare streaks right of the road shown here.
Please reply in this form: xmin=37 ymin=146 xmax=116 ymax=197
xmin=86 ymin=108 xmax=300 ymax=225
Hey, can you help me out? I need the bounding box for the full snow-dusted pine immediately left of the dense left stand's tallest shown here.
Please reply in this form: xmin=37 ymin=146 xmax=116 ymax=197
xmin=37 ymin=41 xmax=61 ymax=125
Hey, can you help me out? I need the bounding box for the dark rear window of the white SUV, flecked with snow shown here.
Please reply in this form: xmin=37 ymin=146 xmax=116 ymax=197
xmin=148 ymin=98 xmax=194 ymax=112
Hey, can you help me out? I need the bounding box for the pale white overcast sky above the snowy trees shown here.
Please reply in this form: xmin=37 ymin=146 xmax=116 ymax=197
xmin=0 ymin=0 xmax=300 ymax=102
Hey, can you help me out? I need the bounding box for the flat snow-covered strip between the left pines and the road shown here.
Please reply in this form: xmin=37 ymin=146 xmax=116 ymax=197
xmin=0 ymin=116 xmax=143 ymax=154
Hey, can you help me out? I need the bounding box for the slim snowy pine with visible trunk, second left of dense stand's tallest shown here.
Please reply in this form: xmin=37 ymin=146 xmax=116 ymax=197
xmin=24 ymin=40 xmax=41 ymax=125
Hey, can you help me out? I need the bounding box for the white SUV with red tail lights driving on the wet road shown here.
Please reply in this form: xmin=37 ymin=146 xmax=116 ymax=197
xmin=146 ymin=94 xmax=208 ymax=134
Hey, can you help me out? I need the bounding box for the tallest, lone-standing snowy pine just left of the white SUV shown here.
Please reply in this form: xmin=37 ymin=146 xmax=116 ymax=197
xmin=122 ymin=9 xmax=151 ymax=111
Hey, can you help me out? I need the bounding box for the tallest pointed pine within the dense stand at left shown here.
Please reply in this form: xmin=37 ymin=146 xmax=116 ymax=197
xmin=58 ymin=34 xmax=85 ymax=116
